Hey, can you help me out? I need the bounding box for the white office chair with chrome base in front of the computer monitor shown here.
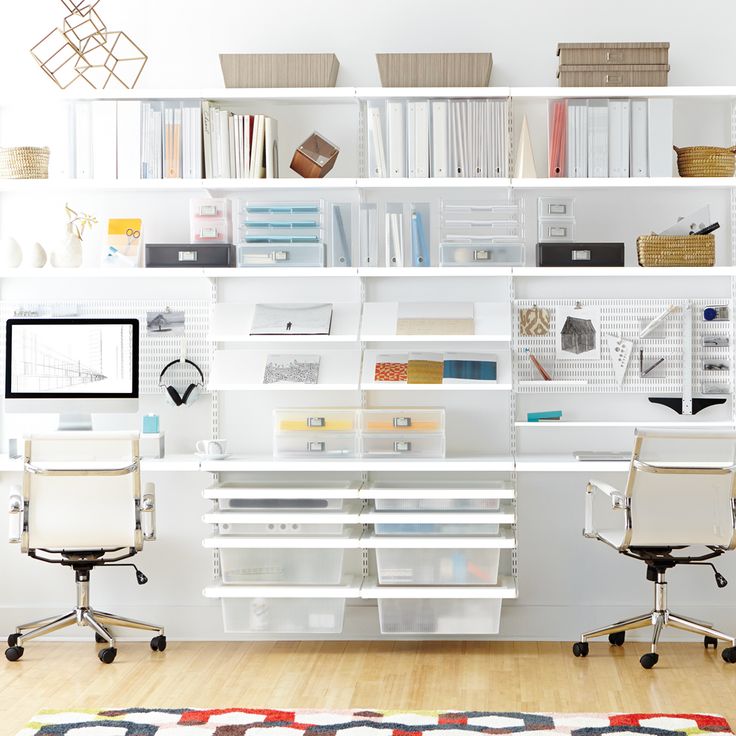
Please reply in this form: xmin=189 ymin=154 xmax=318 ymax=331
xmin=5 ymin=432 xmax=166 ymax=664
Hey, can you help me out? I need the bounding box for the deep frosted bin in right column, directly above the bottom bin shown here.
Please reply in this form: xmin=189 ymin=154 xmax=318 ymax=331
xmin=376 ymin=548 xmax=500 ymax=585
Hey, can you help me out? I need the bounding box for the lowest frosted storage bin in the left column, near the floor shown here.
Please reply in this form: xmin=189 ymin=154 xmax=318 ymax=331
xmin=222 ymin=596 xmax=345 ymax=634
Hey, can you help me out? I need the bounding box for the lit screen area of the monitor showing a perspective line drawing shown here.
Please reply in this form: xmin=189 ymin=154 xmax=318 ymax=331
xmin=11 ymin=325 xmax=133 ymax=395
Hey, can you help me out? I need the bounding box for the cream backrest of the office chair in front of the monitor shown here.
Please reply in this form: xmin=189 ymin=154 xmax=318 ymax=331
xmin=23 ymin=432 xmax=140 ymax=552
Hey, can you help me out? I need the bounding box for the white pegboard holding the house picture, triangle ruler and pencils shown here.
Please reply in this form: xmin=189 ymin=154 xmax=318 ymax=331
xmin=513 ymin=299 xmax=733 ymax=394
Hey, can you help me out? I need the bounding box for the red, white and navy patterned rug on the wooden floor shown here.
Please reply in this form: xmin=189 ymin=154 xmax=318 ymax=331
xmin=18 ymin=708 xmax=731 ymax=736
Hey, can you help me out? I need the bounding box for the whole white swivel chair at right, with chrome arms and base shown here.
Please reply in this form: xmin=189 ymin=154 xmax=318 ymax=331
xmin=573 ymin=430 xmax=736 ymax=669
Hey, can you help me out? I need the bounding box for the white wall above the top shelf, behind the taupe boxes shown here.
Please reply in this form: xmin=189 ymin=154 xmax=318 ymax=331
xmin=0 ymin=0 xmax=736 ymax=93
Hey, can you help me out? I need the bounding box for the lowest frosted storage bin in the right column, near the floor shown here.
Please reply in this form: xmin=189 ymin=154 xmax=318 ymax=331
xmin=378 ymin=598 xmax=501 ymax=634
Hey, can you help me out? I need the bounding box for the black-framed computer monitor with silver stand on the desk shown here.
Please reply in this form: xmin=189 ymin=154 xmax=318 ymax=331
xmin=5 ymin=318 xmax=139 ymax=429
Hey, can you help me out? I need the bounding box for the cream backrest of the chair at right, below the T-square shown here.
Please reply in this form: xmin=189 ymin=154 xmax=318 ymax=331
xmin=626 ymin=430 xmax=736 ymax=547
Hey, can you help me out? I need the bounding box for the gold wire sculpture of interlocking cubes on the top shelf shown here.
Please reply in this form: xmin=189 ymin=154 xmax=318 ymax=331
xmin=31 ymin=0 xmax=148 ymax=89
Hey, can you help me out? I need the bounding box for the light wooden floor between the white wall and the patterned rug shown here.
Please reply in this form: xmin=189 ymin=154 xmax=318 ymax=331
xmin=0 ymin=642 xmax=736 ymax=736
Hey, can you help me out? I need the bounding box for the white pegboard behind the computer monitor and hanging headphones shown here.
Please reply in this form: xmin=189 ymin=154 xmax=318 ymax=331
xmin=0 ymin=299 xmax=210 ymax=396
